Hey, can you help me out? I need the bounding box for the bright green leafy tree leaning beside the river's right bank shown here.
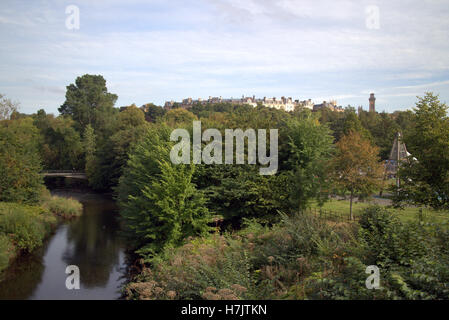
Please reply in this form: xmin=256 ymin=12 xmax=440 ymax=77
xmin=118 ymin=125 xmax=210 ymax=258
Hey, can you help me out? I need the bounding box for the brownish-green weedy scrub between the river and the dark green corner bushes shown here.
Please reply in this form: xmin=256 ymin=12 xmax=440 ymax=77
xmin=126 ymin=214 xmax=354 ymax=299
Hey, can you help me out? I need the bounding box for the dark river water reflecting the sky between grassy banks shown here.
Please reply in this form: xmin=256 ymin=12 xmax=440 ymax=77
xmin=0 ymin=191 xmax=127 ymax=299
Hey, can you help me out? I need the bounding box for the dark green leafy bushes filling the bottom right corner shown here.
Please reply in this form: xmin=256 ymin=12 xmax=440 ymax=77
xmin=300 ymin=206 xmax=449 ymax=299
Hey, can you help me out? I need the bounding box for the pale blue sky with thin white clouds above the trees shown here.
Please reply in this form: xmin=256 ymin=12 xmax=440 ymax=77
xmin=0 ymin=0 xmax=449 ymax=114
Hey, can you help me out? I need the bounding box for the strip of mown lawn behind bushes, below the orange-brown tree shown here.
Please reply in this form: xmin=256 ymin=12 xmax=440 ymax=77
xmin=312 ymin=199 xmax=449 ymax=223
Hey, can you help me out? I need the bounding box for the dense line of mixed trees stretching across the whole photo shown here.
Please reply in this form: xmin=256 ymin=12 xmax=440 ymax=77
xmin=0 ymin=75 xmax=449 ymax=262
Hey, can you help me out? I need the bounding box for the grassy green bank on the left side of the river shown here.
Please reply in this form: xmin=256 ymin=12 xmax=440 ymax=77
xmin=0 ymin=192 xmax=83 ymax=272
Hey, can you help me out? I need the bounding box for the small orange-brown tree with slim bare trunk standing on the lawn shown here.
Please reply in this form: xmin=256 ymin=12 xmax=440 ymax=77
xmin=330 ymin=131 xmax=383 ymax=220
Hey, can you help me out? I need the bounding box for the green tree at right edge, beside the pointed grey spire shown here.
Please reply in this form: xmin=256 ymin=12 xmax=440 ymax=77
xmin=394 ymin=93 xmax=449 ymax=209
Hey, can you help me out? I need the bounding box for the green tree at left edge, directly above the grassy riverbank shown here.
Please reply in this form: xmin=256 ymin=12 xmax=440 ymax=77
xmin=0 ymin=118 xmax=43 ymax=203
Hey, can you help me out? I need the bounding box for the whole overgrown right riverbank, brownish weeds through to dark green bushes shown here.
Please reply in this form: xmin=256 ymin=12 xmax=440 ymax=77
xmin=125 ymin=206 xmax=449 ymax=300
